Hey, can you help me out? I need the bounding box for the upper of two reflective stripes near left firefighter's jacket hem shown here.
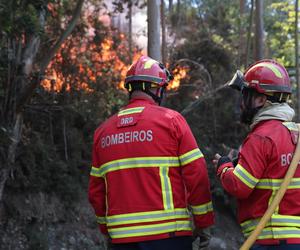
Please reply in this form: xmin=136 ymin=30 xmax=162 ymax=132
xmin=106 ymin=208 xmax=190 ymax=226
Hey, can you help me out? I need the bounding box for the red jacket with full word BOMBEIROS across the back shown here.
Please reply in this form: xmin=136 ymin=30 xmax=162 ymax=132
xmin=89 ymin=98 xmax=213 ymax=243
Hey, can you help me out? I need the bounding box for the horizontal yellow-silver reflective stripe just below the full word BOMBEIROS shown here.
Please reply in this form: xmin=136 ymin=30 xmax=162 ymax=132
xmin=91 ymin=156 xmax=180 ymax=177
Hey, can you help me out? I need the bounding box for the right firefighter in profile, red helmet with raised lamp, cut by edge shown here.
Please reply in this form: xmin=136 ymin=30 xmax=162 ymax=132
xmin=213 ymin=59 xmax=300 ymax=250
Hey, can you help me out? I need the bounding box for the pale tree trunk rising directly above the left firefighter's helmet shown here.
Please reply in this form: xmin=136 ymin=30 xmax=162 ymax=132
xmin=147 ymin=0 xmax=161 ymax=61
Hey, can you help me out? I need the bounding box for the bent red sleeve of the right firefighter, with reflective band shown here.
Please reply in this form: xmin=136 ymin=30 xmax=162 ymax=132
xmin=220 ymin=134 xmax=273 ymax=199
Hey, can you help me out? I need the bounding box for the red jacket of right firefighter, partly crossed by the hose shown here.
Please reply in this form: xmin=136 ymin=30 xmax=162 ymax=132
xmin=218 ymin=120 xmax=300 ymax=243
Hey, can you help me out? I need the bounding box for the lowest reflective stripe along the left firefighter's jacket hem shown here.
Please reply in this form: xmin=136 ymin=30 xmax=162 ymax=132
xmin=108 ymin=221 xmax=192 ymax=239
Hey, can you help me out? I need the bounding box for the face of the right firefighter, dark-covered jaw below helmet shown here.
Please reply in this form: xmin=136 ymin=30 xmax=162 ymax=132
xmin=240 ymin=88 xmax=267 ymax=125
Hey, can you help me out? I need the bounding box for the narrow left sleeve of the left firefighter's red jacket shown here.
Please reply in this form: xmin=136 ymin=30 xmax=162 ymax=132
xmin=88 ymin=133 xmax=108 ymax=234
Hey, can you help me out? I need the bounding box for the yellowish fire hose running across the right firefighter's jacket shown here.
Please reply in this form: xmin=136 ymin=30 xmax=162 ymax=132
xmin=240 ymin=124 xmax=300 ymax=250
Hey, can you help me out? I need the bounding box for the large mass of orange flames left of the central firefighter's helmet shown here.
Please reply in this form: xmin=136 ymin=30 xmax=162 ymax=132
xmin=41 ymin=34 xmax=141 ymax=92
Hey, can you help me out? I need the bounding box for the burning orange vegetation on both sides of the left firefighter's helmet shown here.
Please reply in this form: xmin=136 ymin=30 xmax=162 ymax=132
xmin=42 ymin=5 xmax=188 ymax=93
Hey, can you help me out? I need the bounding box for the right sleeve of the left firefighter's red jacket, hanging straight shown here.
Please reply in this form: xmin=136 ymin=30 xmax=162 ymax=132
xmin=174 ymin=115 xmax=214 ymax=228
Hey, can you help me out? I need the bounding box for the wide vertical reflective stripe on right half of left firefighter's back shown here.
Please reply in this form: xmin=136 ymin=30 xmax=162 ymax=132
xmin=159 ymin=167 xmax=174 ymax=210
